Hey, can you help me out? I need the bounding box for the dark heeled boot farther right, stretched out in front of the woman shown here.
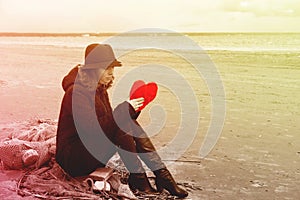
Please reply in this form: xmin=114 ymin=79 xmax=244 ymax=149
xmin=154 ymin=168 xmax=188 ymax=198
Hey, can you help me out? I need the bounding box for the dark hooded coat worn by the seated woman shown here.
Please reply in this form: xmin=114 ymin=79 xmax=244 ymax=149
xmin=56 ymin=66 xmax=138 ymax=176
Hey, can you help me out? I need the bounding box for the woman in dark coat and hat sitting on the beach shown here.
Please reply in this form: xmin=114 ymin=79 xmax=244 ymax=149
xmin=56 ymin=44 xmax=188 ymax=198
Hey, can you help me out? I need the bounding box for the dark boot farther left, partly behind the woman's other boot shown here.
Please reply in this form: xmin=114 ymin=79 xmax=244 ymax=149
xmin=128 ymin=173 xmax=155 ymax=193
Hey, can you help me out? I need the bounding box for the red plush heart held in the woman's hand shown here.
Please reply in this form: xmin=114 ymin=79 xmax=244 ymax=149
xmin=130 ymin=80 xmax=158 ymax=111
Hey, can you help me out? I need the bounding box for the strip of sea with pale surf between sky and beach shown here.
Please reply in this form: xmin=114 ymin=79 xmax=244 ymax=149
xmin=0 ymin=33 xmax=300 ymax=53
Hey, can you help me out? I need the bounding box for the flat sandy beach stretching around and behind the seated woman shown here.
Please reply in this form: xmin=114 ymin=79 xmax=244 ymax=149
xmin=0 ymin=45 xmax=300 ymax=200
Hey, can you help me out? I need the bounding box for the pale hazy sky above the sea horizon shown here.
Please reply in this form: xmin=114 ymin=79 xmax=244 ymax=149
xmin=0 ymin=0 xmax=300 ymax=33
